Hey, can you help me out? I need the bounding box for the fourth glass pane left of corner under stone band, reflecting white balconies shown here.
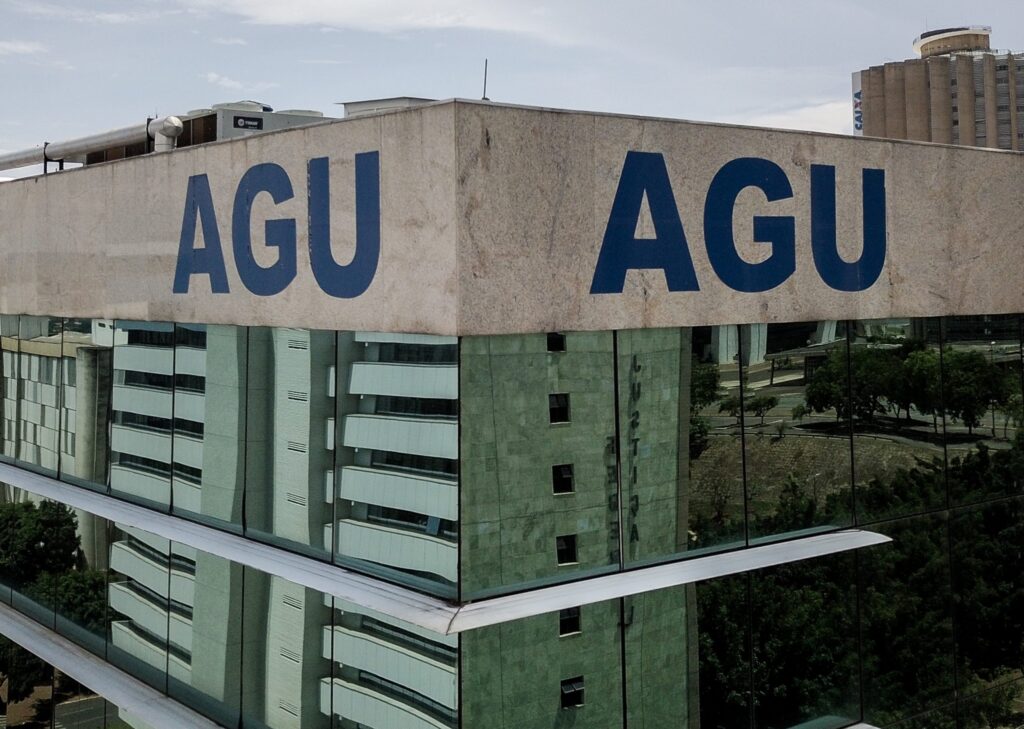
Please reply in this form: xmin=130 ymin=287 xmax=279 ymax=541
xmin=111 ymin=321 xmax=174 ymax=511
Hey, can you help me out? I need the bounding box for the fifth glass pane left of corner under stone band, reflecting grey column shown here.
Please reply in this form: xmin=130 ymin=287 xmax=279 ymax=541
xmin=60 ymin=318 xmax=114 ymax=491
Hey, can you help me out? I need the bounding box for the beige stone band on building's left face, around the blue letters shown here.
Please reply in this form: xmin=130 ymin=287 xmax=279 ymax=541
xmin=0 ymin=104 xmax=456 ymax=332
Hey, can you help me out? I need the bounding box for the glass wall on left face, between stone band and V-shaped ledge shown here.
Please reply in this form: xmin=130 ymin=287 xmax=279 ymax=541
xmin=0 ymin=315 xmax=459 ymax=598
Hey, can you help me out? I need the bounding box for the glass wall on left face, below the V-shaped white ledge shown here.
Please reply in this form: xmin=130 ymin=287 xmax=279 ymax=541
xmin=0 ymin=486 xmax=459 ymax=729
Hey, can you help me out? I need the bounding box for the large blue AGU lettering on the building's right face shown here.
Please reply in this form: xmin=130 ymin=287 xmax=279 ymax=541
xmin=590 ymin=152 xmax=886 ymax=294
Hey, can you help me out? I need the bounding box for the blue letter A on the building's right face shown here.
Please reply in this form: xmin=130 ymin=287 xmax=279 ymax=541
xmin=590 ymin=152 xmax=700 ymax=294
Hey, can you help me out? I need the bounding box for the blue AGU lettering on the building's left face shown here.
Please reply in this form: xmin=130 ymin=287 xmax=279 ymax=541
xmin=174 ymin=152 xmax=381 ymax=299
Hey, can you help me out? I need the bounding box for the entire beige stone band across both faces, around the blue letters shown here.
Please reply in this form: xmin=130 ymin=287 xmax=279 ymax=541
xmin=0 ymin=100 xmax=1024 ymax=334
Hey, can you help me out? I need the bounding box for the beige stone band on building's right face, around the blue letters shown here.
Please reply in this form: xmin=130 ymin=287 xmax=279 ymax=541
xmin=457 ymin=103 xmax=1024 ymax=333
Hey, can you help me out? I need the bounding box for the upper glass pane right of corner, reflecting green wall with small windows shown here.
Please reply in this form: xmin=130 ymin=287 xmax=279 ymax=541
xmin=459 ymin=332 xmax=620 ymax=602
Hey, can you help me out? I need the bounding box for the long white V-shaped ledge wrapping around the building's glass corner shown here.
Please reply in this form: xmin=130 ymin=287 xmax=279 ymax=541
xmin=0 ymin=463 xmax=892 ymax=635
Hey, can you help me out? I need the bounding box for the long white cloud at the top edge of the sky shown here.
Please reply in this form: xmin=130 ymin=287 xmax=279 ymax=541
xmin=172 ymin=0 xmax=579 ymax=44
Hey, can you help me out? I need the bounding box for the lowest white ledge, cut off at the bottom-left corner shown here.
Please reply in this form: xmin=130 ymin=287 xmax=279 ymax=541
xmin=0 ymin=603 xmax=220 ymax=729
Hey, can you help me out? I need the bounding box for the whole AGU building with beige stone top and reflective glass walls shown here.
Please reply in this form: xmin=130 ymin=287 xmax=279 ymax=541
xmin=0 ymin=101 xmax=1024 ymax=729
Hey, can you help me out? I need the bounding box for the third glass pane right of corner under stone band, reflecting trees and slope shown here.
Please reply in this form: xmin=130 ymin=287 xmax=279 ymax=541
xmin=742 ymin=320 xmax=853 ymax=540
